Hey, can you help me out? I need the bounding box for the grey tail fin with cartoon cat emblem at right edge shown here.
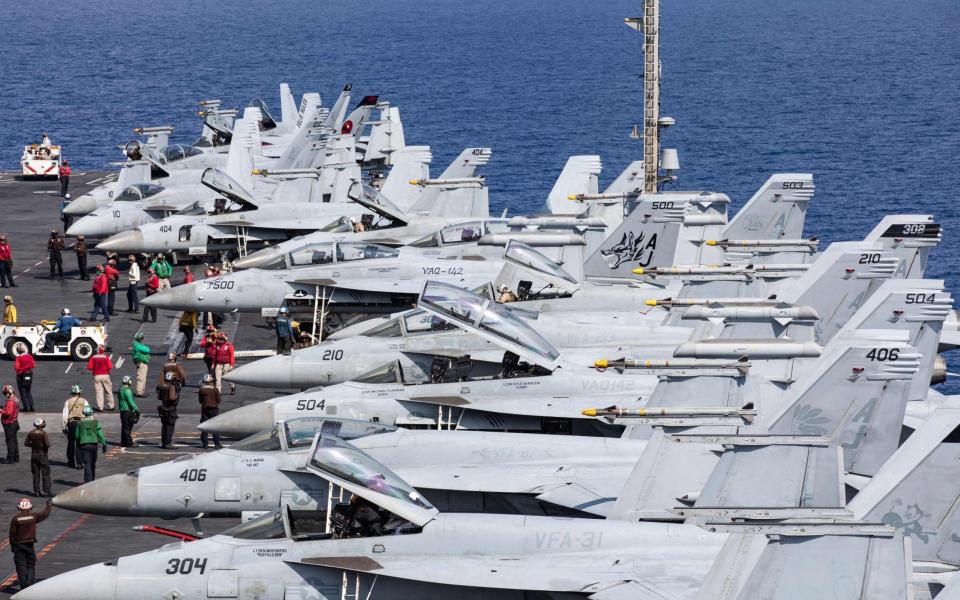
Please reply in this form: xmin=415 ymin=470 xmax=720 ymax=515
xmin=848 ymin=396 xmax=960 ymax=567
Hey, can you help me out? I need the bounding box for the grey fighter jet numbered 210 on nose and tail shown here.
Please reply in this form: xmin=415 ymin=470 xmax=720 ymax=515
xmin=216 ymin=230 xmax=908 ymax=389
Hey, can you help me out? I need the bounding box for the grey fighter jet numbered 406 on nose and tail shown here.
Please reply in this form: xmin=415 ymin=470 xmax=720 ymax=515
xmin=50 ymin=282 xmax=936 ymax=518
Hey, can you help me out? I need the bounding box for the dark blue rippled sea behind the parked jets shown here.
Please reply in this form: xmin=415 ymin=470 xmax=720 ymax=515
xmin=0 ymin=0 xmax=960 ymax=390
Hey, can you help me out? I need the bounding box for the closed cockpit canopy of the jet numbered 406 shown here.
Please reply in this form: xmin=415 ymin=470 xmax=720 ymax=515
xmin=231 ymin=417 xmax=396 ymax=452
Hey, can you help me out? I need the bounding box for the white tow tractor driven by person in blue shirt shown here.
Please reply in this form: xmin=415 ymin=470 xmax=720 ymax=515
xmin=0 ymin=321 xmax=107 ymax=360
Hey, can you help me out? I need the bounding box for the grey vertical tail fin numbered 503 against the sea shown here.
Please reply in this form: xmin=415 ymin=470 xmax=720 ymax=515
xmin=723 ymin=173 xmax=814 ymax=240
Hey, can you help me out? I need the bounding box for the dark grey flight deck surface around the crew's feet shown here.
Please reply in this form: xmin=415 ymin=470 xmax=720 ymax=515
xmin=0 ymin=169 xmax=283 ymax=599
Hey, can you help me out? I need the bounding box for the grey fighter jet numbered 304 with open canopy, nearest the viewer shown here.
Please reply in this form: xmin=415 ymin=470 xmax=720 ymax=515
xmin=26 ymin=378 xmax=924 ymax=600
